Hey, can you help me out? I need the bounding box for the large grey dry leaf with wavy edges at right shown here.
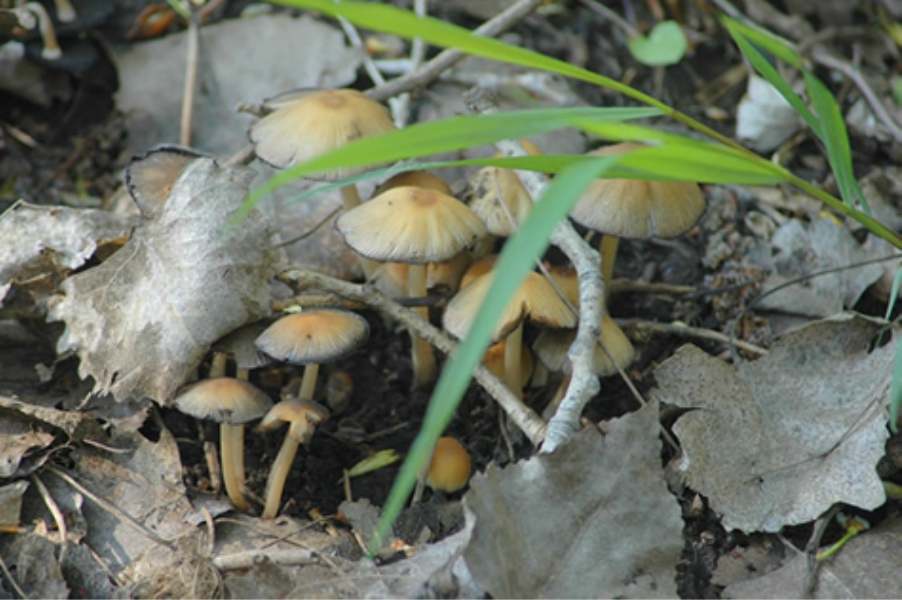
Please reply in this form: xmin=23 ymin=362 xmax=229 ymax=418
xmin=653 ymin=315 xmax=896 ymax=532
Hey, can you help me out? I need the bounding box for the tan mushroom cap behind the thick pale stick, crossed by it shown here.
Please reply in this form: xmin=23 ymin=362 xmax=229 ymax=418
xmin=533 ymin=314 xmax=636 ymax=377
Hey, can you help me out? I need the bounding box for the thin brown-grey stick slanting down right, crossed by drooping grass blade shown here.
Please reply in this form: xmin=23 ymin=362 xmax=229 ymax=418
xmin=276 ymin=269 xmax=545 ymax=445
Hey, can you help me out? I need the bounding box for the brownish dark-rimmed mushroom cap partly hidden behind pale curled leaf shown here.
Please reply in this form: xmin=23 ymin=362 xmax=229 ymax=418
xmin=125 ymin=146 xmax=206 ymax=218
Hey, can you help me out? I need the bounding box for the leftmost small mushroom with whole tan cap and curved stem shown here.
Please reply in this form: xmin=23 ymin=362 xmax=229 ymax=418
xmin=175 ymin=376 xmax=272 ymax=512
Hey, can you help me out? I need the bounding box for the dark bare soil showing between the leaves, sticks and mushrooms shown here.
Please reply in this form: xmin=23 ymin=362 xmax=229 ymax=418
xmin=0 ymin=2 xmax=892 ymax=598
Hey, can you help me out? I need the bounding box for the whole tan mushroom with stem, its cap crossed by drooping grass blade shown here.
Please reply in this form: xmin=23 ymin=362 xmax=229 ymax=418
xmin=442 ymin=271 xmax=576 ymax=397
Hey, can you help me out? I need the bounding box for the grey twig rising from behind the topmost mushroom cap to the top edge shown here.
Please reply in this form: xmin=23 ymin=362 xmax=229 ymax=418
xmin=367 ymin=0 xmax=543 ymax=101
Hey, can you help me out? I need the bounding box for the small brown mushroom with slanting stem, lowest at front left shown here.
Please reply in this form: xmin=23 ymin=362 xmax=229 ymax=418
xmin=257 ymin=398 xmax=329 ymax=519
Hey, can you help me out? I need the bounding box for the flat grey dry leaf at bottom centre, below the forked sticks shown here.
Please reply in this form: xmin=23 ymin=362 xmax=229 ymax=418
xmin=464 ymin=403 xmax=683 ymax=598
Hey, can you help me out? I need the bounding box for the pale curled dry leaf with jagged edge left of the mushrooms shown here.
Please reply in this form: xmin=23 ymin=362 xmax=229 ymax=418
xmin=50 ymin=158 xmax=272 ymax=403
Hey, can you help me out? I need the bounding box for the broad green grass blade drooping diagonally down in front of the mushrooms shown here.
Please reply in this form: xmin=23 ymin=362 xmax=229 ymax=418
xmin=377 ymin=157 xmax=616 ymax=552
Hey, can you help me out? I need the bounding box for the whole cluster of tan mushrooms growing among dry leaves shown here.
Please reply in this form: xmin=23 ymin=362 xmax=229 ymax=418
xmin=176 ymin=89 xmax=705 ymax=518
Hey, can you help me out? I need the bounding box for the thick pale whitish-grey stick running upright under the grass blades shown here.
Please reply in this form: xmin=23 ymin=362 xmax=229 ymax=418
xmin=465 ymin=88 xmax=604 ymax=453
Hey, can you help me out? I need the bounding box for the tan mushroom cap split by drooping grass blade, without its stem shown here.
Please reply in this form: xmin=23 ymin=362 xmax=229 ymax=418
xmin=442 ymin=271 xmax=576 ymax=342
